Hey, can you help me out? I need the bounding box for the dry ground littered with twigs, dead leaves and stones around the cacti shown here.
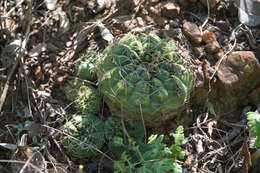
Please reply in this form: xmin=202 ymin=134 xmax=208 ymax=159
xmin=0 ymin=0 xmax=260 ymax=173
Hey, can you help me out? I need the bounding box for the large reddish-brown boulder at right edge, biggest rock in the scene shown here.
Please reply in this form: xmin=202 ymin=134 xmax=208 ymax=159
xmin=210 ymin=51 xmax=260 ymax=114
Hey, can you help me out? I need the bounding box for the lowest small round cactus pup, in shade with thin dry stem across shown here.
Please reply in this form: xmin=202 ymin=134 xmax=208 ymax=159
xmin=62 ymin=114 xmax=105 ymax=158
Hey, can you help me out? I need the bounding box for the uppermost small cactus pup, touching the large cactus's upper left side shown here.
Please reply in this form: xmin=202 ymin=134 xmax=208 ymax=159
xmin=75 ymin=52 xmax=98 ymax=81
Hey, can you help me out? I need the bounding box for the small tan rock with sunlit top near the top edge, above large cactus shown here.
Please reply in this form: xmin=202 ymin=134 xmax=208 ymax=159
xmin=162 ymin=1 xmax=180 ymax=18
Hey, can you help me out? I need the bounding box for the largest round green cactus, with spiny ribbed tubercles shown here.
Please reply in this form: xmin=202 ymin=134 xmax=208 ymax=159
xmin=97 ymin=33 xmax=194 ymax=126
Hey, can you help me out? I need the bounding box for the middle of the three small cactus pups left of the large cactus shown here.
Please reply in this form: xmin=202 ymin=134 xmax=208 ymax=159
xmin=65 ymin=79 xmax=101 ymax=114
